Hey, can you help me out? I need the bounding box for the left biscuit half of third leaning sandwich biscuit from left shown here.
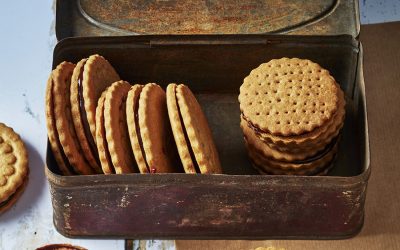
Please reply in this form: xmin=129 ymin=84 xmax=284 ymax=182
xmin=95 ymin=90 xmax=115 ymax=174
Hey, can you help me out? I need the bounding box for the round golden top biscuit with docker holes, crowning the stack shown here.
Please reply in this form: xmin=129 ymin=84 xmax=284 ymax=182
xmin=239 ymin=58 xmax=338 ymax=136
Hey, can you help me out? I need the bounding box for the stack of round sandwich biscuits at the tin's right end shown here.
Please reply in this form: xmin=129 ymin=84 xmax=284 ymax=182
xmin=239 ymin=58 xmax=345 ymax=175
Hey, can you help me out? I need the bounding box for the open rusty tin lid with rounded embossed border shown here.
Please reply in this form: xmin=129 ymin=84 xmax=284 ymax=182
xmin=56 ymin=0 xmax=360 ymax=40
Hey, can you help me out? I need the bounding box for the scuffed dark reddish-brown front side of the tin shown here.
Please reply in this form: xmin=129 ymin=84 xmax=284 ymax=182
xmin=47 ymin=174 xmax=365 ymax=239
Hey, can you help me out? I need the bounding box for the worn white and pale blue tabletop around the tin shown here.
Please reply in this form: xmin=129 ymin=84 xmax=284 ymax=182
xmin=0 ymin=0 xmax=400 ymax=250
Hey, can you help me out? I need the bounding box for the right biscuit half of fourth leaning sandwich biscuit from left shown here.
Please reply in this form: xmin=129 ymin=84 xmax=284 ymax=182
xmin=135 ymin=83 xmax=182 ymax=173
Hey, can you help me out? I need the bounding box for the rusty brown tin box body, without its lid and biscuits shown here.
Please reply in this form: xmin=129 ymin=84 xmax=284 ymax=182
xmin=46 ymin=35 xmax=370 ymax=239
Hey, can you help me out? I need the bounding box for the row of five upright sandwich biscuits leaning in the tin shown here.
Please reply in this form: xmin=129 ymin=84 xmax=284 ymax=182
xmin=46 ymin=55 xmax=222 ymax=175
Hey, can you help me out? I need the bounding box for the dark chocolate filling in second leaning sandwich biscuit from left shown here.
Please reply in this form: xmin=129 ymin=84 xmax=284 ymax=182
xmin=78 ymin=63 xmax=100 ymax=165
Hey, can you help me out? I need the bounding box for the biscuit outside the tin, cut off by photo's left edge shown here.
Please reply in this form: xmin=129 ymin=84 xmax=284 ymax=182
xmin=0 ymin=123 xmax=29 ymax=214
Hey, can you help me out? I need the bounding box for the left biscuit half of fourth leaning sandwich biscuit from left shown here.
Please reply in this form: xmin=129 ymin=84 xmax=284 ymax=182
xmin=126 ymin=84 xmax=151 ymax=174
